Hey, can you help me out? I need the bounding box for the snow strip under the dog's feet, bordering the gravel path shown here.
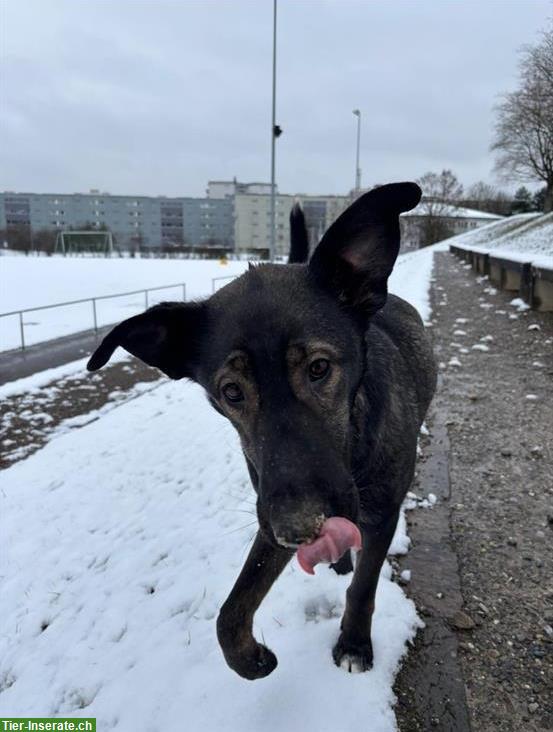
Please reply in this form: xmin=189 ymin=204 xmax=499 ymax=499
xmin=0 ymin=249 xmax=433 ymax=732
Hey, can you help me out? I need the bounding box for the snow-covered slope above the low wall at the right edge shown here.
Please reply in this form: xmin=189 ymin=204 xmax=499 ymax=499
xmin=444 ymin=213 xmax=553 ymax=266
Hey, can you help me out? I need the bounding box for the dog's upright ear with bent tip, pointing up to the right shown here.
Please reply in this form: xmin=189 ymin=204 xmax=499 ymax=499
xmin=309 ymin=183 xmax=421 ymax=315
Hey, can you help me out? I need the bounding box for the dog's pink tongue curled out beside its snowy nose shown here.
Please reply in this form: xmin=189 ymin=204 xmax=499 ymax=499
xmin=298 ymin=516 xmax=361 ymax=574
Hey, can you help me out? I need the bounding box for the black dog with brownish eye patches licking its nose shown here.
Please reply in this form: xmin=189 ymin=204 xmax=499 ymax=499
xmin=88 ymin=183 xmax=436 ymax=679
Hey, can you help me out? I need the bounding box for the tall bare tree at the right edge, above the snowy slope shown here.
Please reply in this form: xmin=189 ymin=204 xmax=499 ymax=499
xmin=491 ymin=26 xmax=553 ymax=212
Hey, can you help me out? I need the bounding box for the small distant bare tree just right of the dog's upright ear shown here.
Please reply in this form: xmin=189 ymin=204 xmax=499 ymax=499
xmin=413 ymin=170 xmax=463 ymax=246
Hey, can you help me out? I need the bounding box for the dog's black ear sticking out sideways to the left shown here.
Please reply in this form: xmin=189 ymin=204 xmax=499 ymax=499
xmin=86 ymin=302 xmax=206 ymax=379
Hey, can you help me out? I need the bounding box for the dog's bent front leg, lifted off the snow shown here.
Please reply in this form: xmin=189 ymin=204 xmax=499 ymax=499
xmin=217 ymin=532 xmax=293 ymax=679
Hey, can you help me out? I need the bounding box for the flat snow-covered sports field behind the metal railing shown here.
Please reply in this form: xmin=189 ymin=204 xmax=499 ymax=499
xmin=0 ymin=249 xmax=432 ymax=351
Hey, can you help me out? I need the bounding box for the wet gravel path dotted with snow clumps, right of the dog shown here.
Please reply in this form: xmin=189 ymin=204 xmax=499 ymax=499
xmin=396 ymin=254 xmax=553 ymax=732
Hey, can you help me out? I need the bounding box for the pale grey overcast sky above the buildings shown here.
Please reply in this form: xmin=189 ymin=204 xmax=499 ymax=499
xmin=0 ymin=0 xmax=553 ymax=196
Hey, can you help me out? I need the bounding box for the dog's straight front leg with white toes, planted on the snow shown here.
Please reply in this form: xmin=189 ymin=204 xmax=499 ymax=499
xmin=332 ymin=511 xmax=399 ymax=672
